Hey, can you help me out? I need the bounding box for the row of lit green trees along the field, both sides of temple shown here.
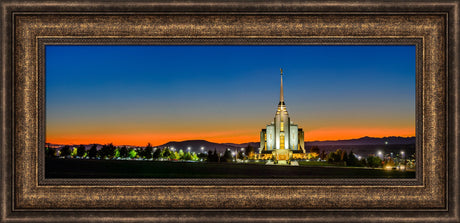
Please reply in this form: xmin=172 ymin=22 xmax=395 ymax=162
xmin=45 ymin=143 xmax=402 ymax=168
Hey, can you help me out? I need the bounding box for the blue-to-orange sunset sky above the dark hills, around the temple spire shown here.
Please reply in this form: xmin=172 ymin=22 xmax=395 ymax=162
xmin=46 ymin=45 xmax=415 ymax=145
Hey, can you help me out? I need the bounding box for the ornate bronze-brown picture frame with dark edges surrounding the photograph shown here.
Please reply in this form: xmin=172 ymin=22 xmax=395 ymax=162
xmin=1 ymin=1 xmax=459 ymax=222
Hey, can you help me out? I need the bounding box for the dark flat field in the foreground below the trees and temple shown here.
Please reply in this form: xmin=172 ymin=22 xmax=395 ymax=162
xmin=45 ymin=159 xmax=415 ymax=178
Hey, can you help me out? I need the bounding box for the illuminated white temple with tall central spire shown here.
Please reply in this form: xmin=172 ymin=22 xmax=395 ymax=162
xmin=260 ymin=69 xmax=306 ymax=163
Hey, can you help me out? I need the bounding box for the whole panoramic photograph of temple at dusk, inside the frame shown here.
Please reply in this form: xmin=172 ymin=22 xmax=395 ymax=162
xmin=43 ymin=45 xmax=417 ymax=179
